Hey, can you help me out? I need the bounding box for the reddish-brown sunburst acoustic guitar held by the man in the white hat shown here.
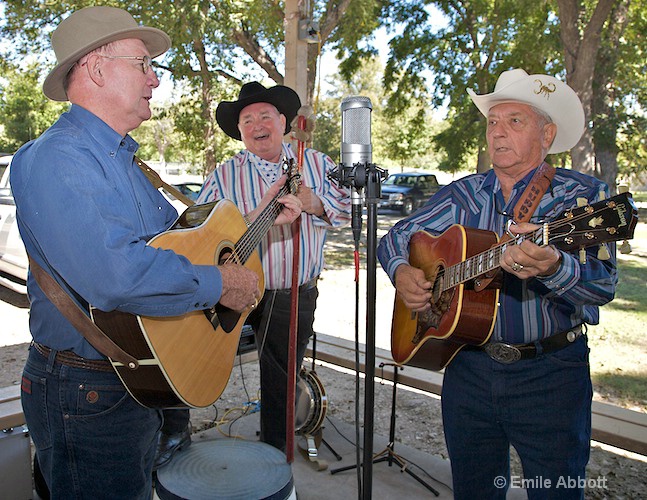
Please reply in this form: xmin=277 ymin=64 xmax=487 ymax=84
xmin=391 ymin=193 xmax=638 ymax=370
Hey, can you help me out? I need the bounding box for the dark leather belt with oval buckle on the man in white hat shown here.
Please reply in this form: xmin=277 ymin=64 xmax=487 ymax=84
xmin=468 ymin=325 xmax=582 ymax=364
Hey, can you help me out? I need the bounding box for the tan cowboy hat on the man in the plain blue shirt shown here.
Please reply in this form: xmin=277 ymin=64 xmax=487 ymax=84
xmin=43 ymin=6 xmax=171 ymax=101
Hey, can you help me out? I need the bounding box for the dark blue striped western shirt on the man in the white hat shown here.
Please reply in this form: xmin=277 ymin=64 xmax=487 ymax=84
xmin=378 ymin=164 xmax=617 ymax=343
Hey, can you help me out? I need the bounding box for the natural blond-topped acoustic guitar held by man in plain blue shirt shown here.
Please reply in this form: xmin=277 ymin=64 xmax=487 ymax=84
xmin=90 ymin=160 xmax=299 ymax=408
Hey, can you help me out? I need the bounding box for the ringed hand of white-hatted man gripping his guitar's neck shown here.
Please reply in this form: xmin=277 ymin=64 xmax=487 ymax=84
xmin=500 ymin=222 xmax=562 ymax=279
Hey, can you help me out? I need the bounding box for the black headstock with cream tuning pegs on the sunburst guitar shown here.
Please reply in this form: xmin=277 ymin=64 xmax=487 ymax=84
xmin=549 ymin=193 xmax=638 ymax=250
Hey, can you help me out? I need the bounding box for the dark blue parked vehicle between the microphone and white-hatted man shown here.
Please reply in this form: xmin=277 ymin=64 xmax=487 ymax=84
xmin=378 ymin=172 xmax=441 ymax=215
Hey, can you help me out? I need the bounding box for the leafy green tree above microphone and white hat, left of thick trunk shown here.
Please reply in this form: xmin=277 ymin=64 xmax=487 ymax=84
xmin=384 ymin=0 xmax=559 ymax=172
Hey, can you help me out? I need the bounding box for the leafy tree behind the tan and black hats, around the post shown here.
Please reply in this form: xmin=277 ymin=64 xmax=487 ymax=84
xmin=0 ymin=0 xmax=381 ymax=169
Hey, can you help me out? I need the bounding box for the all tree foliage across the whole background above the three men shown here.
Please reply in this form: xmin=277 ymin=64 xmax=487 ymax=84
xmin=0 ymin=0 xmax=647 ymax=188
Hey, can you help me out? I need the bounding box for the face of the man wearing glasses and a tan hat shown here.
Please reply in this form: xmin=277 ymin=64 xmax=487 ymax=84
xmin=96 ymin=38 xmax=160 ymax=134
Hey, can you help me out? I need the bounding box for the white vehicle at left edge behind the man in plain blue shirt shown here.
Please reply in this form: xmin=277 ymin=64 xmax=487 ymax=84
xmin=0 ymin=155 xmax=28 ymax=294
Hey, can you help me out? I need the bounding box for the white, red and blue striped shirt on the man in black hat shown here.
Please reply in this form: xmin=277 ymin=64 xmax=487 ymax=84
xmin=198 ymin=143 xmax=350 ymax=290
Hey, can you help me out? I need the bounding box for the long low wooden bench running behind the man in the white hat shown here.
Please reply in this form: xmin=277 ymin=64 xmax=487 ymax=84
xmin=307 ymin=334 xmax=647 ymax=455
